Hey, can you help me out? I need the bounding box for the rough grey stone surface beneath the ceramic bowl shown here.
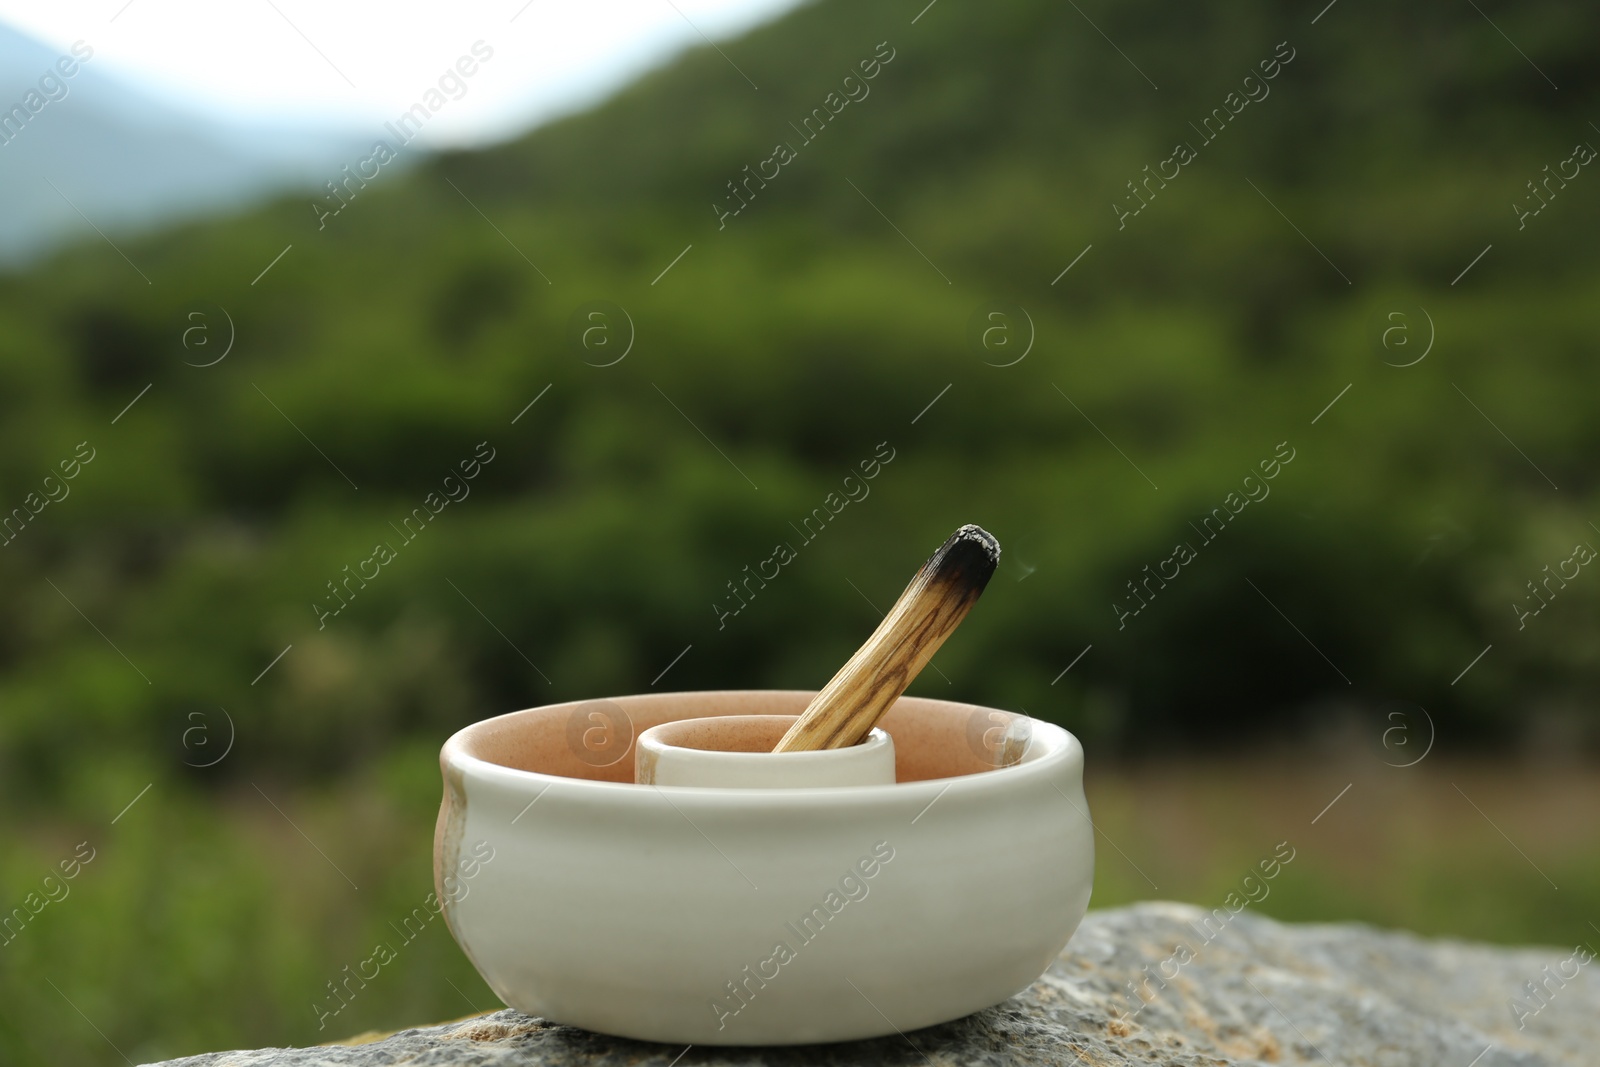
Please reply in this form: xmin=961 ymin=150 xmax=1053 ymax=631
xmin=144 ymin=904 xmax=1600 ymax=1067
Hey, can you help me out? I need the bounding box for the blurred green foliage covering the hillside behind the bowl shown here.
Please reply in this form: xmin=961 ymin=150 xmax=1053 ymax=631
xmin=0 ymin=0 xmax=1600 ymax=1062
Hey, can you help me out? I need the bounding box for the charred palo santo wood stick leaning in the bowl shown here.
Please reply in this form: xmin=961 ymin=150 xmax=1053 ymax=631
xmin=773 ymin=525 xmax=1000 ymax=752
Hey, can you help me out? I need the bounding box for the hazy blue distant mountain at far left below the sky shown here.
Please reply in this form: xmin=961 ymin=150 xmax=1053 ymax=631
xmin=0 ymin=26 xmax=366 ymax=266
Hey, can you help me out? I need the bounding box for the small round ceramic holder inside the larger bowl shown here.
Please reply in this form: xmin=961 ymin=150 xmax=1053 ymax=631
xmin=634 ymin=715 xmax=894 ymax=789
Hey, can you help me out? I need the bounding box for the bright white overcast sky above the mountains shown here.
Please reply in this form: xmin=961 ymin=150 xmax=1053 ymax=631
xmin=0 ymin=0 xmax=798 ymax=146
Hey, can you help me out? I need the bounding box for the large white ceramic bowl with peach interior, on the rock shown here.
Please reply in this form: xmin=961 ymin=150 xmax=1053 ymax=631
xmin=434 ymin=691 xmax=1094 ymax=1045
